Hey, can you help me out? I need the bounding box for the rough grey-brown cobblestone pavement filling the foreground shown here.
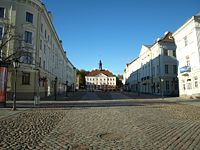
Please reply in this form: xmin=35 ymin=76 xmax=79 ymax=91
xmin=0 ymin=104 xmax=200 ymax=150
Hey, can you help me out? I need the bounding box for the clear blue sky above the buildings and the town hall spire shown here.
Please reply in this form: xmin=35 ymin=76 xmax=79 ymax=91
xmin=43 ymin=0 xmax=200 ymax=74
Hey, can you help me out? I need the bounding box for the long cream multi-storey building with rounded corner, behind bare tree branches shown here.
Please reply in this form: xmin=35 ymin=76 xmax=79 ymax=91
xmin=0 ymin=0 xmax=76 ymax=99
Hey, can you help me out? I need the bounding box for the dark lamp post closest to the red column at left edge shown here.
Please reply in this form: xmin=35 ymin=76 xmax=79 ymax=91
xmin=12 ymin=60 xmax=19 ymax=110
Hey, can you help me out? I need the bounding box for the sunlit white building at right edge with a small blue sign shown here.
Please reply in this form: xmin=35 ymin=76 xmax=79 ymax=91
xmin=173 ymin=14 xmax=200 ymax=98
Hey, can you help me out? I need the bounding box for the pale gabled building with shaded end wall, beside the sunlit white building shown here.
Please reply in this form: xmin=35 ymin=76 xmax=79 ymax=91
xmin=124 ymin=32 xmax=178 ymax=96
